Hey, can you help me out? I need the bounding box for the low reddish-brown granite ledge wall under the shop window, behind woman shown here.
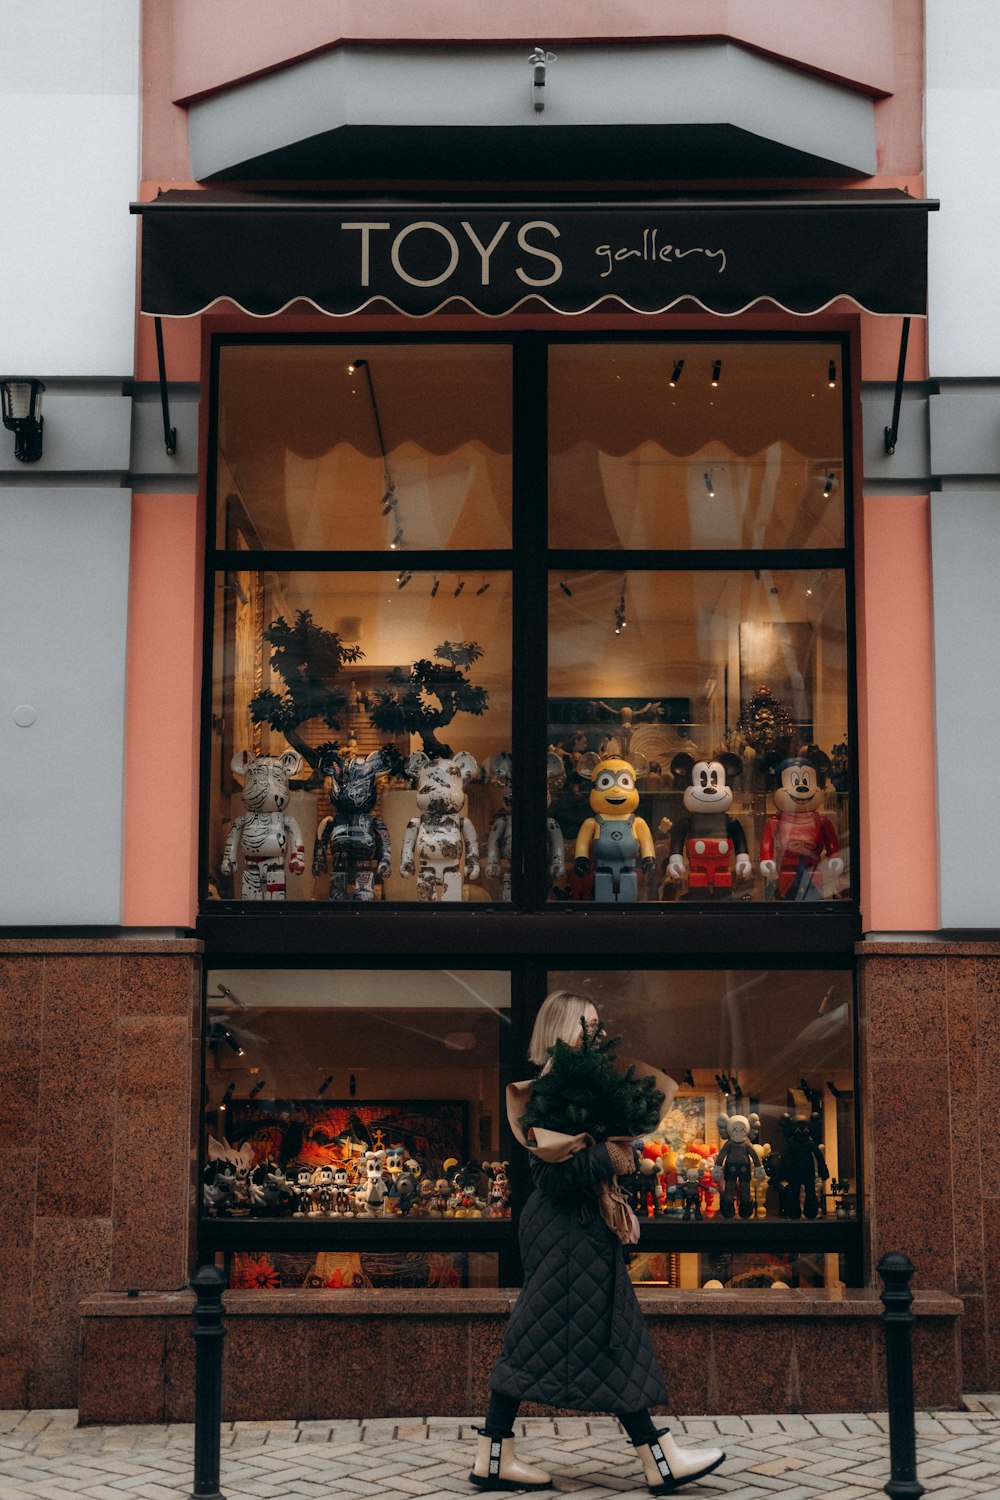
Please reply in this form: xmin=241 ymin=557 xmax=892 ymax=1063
xmin=79 ymin=1289 xmax=963 ymax=1425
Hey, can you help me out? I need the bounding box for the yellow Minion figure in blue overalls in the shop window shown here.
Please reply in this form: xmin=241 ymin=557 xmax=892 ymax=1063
xmin=573 ymin=755 xmax=657 ymax=902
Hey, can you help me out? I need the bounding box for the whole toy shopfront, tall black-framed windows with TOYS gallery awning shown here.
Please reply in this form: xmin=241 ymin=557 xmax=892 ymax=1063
xmin=58 ymin=181 xmax=954 ymax=1412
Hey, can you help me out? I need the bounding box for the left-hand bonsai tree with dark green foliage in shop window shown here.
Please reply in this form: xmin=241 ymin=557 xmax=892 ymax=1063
xmin=250 ymin=609 xmax=364 ymax=783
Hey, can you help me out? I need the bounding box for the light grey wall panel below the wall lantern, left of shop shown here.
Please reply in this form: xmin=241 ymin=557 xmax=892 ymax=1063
xmin=0 ymin=489 xmax=132 ymax=927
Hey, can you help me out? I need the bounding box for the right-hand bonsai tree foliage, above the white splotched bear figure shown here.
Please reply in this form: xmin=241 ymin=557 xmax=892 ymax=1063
xmin=370 ymin=641 xmax=489 ymax=761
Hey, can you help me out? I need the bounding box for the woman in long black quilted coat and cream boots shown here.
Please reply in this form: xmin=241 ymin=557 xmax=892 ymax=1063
xmin=469 ymin=990 xmax=726 ymax=1494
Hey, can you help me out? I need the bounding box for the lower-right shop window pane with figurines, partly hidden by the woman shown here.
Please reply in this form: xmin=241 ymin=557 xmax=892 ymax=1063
xmin=549 ymin=969 xmax=858 ymax=1230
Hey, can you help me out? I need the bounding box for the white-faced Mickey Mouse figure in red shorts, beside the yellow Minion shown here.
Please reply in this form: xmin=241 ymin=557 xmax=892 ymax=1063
xmin=667 ymin=750 xmax=751 ymax=900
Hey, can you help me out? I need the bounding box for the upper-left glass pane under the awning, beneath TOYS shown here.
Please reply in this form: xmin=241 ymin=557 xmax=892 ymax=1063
xmin=216 ymin=341 xmax=511 ymax=551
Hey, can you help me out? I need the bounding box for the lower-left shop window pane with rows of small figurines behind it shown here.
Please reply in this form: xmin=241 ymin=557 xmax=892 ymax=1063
xmin=202 ymin=969 xmax=510 ymax=1230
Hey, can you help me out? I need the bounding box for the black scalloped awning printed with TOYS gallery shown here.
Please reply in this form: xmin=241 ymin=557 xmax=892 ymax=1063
xmin=132 ymin=189 xmax=937 ymax=318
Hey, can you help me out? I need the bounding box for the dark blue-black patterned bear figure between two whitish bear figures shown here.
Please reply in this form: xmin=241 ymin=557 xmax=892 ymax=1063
xmin=312 ymin=746 xmax=399 ymax=902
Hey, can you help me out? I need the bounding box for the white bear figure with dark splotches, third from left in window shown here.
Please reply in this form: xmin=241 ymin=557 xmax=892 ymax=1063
xmin=399 ymin=750 xmax=480 ymax=902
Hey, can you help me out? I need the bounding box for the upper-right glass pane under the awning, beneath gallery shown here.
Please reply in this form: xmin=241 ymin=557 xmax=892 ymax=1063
xmin=549 ymin=341 xmax=844 ymax=549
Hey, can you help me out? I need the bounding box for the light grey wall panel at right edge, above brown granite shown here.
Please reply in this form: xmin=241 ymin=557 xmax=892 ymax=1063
xmin=929 ymin=488 xmax=1000 ymax=929
